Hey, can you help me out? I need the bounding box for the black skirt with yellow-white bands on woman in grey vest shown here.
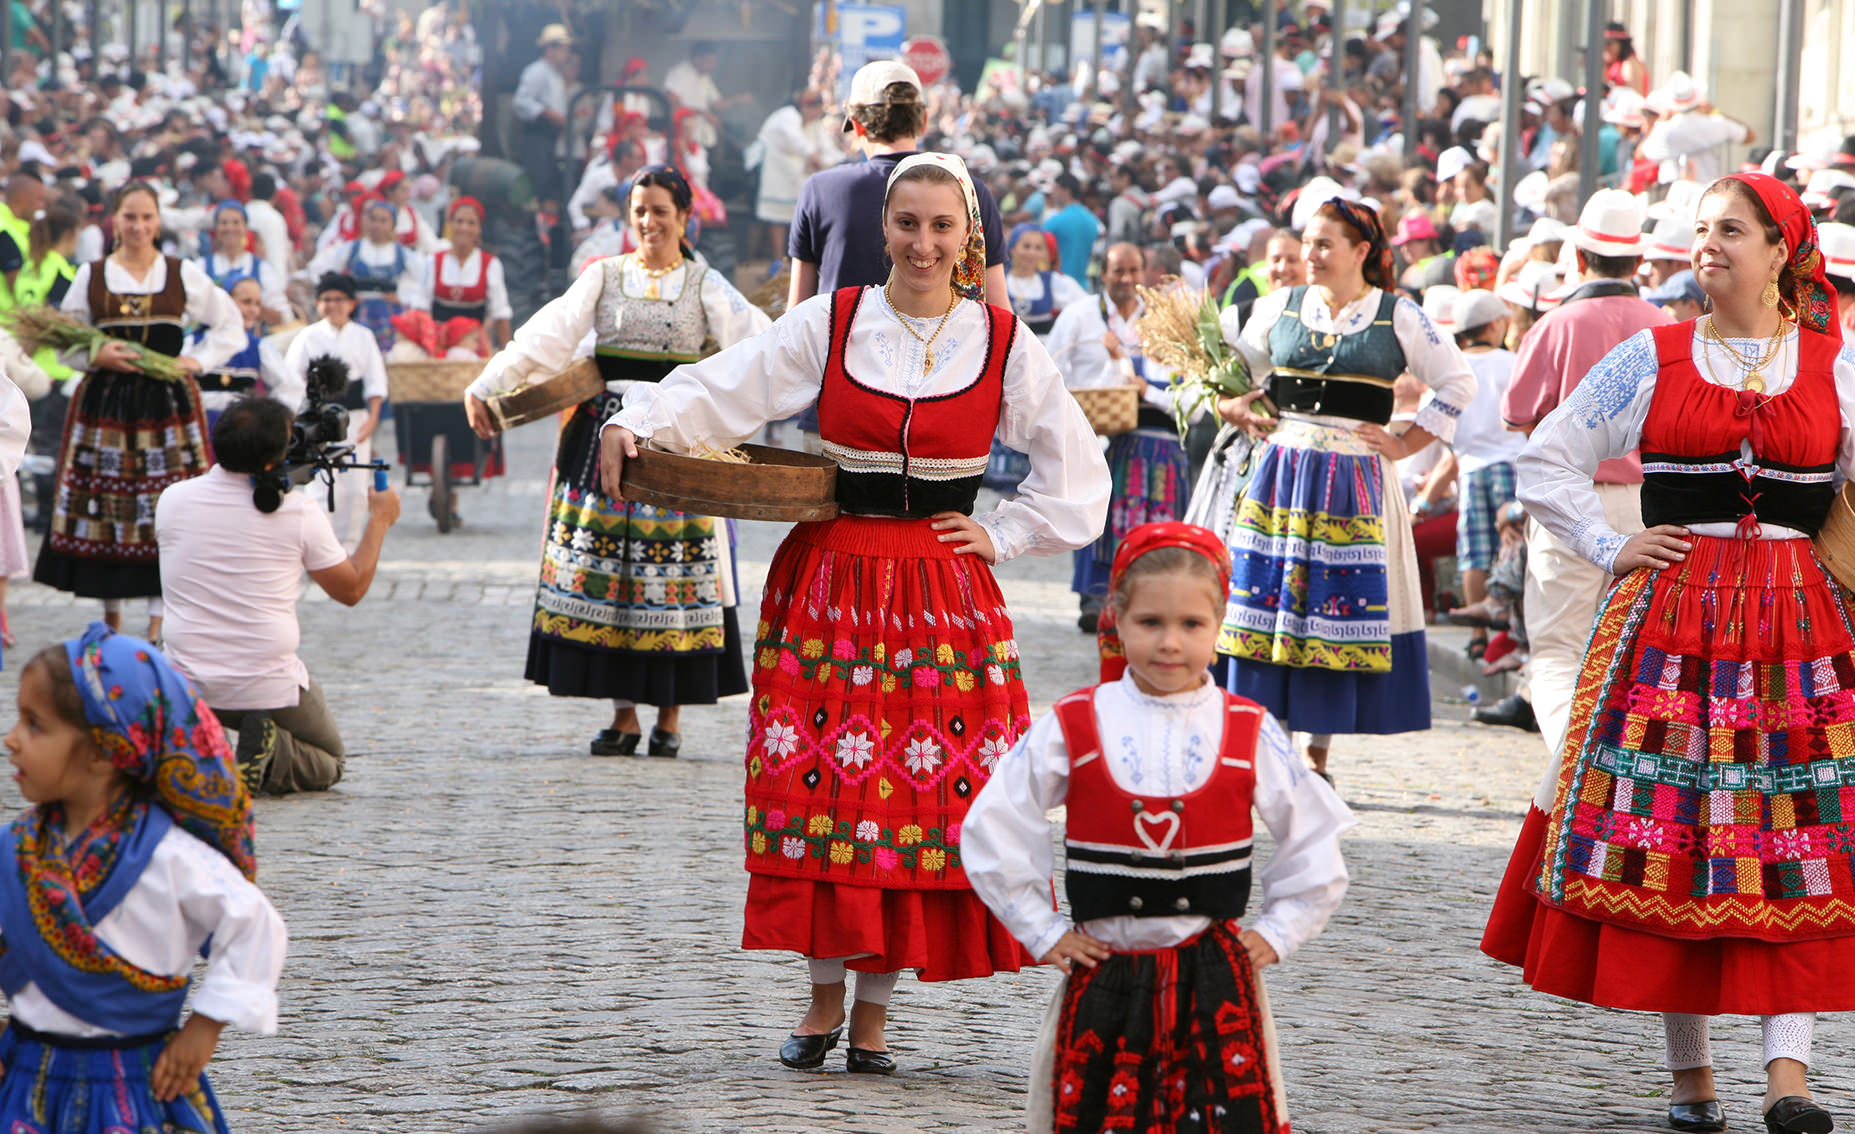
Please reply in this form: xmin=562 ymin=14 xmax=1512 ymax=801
xmin=527 ymin=393 xmax=748 ymax=705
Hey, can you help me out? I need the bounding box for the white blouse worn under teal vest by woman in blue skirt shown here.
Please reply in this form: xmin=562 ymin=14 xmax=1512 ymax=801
xmin=1222 ymin=288 xmax=1475 ymax=445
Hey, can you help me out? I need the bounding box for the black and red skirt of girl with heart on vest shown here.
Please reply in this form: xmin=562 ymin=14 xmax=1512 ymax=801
xmin=1048 ymin=922 xmax=1289 ymax=1134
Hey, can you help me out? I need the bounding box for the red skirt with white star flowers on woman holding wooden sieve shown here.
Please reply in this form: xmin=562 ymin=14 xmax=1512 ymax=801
xmin=742 ymin=516 xmax=1030 ymax=980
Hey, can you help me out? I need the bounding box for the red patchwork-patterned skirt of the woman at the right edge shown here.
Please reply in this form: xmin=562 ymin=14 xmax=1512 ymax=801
xmin=1482 ymin=536 xmax=1855 ymax=1015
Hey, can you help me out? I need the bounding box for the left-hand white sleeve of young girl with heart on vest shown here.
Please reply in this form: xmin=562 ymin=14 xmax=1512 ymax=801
xmin=959 ymin=713 xmax=1068 ymax=960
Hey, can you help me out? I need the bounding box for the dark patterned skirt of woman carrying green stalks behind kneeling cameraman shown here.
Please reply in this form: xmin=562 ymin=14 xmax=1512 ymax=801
xmin=33 ymin=369 xmax=211 ymax=598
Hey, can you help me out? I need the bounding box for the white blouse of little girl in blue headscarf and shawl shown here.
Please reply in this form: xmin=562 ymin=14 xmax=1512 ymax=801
xmin=7 ymin=828 xmax=289 ymax=1036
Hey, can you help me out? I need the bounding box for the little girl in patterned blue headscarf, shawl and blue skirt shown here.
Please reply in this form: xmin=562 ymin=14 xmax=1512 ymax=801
xmin=0 ymin=622 xmax=288 ymax=1134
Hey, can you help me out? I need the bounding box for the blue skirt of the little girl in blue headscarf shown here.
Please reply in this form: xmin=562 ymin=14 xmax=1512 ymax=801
xmin=0 ymin=1024 xmax=228 ymax=1134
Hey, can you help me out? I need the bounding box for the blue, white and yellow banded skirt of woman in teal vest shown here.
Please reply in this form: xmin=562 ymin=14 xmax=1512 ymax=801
xmin=1217 ymin=419 xmax=1430 ymax=733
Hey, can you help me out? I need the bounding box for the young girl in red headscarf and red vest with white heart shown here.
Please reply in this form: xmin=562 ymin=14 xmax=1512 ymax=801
xmin=961 ymin=523 xmax=1352 ymax=1134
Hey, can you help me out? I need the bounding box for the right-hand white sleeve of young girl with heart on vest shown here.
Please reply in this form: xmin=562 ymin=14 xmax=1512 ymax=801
xmin=1248 ymin=715 xmax=1358 ymax=961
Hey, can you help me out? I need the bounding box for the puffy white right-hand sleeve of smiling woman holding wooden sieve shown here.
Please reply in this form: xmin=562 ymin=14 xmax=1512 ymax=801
xmin=976 ymin=319 xmax=1109 ymax=562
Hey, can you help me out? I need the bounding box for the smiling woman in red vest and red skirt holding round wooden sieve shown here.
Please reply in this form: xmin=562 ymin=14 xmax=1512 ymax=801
xmin=603 ymin=154 xmax=1107 ymax=1075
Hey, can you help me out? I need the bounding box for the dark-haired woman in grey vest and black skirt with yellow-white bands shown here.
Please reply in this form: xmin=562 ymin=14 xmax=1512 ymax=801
xmin=464 ymin=165 xmax=770 ymax=755
